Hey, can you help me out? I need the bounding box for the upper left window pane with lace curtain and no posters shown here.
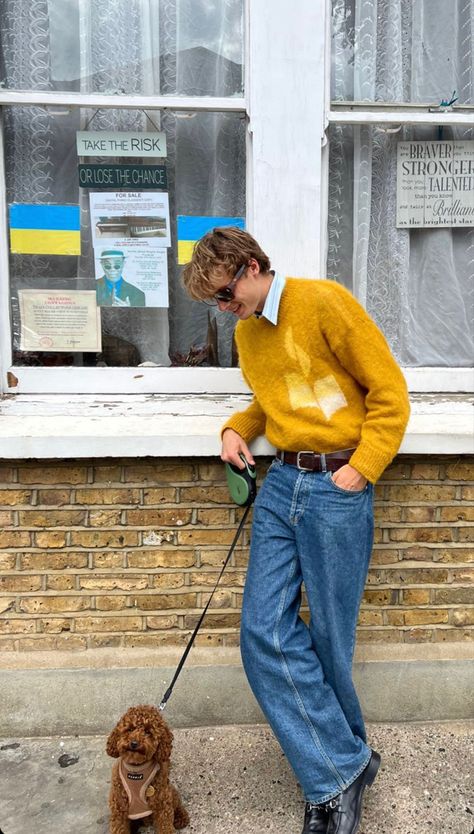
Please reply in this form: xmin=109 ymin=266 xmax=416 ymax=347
xmin=0 ymin=0 xmax=244 ymax=96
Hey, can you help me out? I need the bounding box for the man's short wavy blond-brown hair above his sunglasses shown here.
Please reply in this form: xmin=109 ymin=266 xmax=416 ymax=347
xmin=182 ymin=226 xmax=270 ymax=301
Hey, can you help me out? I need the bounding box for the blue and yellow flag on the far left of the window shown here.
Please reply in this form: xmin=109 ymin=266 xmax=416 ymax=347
xmin=10 ymin=203 xmax=81 ymax=255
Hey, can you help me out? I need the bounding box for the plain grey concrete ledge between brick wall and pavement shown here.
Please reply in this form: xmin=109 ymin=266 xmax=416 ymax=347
xmin=0 ymin=643 xmax=474 ymax=736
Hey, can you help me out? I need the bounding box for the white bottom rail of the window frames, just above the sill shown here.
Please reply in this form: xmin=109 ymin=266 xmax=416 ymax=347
xmin=6 ymin=366 xmax=474 ymax=396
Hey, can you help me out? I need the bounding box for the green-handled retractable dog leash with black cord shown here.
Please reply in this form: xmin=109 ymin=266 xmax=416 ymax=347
xmin=159 ymin=455 xmax=257 ymax=710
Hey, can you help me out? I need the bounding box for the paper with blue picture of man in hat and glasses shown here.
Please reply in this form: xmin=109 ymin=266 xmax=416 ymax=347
xmin=95 ymin=246 xmax=168 ymax=307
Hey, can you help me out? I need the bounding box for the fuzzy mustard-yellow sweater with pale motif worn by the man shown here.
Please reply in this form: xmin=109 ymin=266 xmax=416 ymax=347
xmin=222 ymin=278 xmax=409 ymax=483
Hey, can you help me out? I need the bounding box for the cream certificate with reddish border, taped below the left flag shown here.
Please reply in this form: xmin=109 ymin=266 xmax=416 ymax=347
xmin=18 ymin=290 xmax=102 ymax=353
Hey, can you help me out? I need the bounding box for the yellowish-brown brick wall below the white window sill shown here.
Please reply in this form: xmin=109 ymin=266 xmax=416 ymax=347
xmin=0 ymin=456 xmax=474 ymax=651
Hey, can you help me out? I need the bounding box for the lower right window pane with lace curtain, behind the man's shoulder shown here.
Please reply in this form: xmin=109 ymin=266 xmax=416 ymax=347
xmin=327 ymin=125 xmax=474 ymax=367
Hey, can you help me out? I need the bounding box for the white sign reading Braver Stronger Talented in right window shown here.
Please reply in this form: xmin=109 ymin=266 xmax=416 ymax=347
xmin=397 ymin=140 xmax=474 ymax=229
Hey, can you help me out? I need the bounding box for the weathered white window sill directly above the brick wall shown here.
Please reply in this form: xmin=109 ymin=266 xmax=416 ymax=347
xmin=0 ymin=394 xmax=474 ymax=459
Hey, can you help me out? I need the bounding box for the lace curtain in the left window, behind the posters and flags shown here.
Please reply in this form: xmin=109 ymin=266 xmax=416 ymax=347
xmin=0 ymin=0 xmax=245 ymax=365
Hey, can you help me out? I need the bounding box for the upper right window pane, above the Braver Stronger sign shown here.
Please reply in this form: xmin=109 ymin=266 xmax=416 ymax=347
xmin=331 ymin=0 xmax=474 ymax=105
